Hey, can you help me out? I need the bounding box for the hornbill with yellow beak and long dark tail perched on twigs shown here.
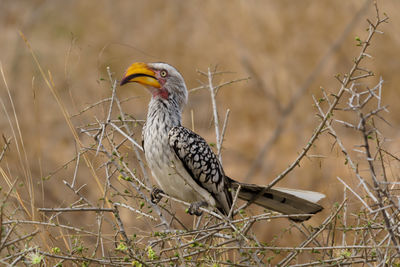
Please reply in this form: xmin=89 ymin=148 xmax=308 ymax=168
xmin=120 ymin=62 xmax=325 ymax=222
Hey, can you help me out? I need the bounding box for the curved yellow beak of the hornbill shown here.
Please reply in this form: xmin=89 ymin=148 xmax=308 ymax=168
xmin=120 ymin=62 xmax=161 ymax=88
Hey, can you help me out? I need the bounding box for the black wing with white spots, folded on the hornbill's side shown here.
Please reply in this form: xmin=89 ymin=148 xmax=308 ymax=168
xmin=168 ymin=126 xmax=232 ymax=215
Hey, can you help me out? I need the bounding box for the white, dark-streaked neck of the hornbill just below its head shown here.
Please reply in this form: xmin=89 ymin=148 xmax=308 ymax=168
xmin=146 ymin=96 xmax=182 ymax=134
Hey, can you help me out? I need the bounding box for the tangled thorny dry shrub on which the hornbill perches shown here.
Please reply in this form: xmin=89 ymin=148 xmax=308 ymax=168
xmin=0 ymin=3 xmax=400 ymax=266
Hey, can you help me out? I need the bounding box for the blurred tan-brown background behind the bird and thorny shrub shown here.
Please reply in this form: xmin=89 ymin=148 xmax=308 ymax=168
xmin=0 ymin=0 xmax=400 ymax=245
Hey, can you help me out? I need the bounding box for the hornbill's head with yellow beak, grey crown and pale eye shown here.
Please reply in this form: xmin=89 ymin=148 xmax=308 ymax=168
xmin=120 ymin=62 xmax=188 ymax=107
